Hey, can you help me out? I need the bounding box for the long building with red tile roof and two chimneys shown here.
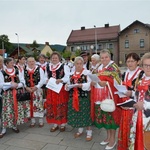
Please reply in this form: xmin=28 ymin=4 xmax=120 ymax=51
xmin=66 ymin=24 xmax=120 ymax=63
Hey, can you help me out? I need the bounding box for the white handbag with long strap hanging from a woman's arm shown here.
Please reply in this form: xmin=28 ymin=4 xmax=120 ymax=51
xmin=100 ymin=82 xmax=116 ymax=112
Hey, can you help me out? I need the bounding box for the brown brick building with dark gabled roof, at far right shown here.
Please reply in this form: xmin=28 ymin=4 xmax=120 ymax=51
xmin=119 ymin=20 xmax=150 ymax=66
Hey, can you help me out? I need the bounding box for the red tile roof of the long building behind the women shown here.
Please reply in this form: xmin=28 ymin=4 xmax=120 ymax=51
xmin=67 ymin=25 xmax=120 ymax=44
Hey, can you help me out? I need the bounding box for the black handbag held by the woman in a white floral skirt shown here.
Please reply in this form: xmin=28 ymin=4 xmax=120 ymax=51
xmin=17 ymin=83 xmax=30 ymax=101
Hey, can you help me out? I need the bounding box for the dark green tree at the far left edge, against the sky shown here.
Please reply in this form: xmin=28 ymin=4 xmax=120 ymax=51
xmin=0 ymin=34 xmax=14 ymax=54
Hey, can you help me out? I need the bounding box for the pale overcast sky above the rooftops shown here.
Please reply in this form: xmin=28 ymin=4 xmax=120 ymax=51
xmin=0 ymin=0 xmax=150 ymax=45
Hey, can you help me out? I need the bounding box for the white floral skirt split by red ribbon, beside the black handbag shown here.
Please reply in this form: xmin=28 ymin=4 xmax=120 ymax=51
xmin=2 ymin=90 xmax=30 ymax=128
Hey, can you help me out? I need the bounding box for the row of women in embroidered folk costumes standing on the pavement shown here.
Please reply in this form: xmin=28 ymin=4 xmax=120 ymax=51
xmin=0 ymin=50 xmax=150 ymax=150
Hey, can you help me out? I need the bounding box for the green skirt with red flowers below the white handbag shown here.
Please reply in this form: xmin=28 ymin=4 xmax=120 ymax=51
xmin=95 ymin=104 xmax=119 ymax=130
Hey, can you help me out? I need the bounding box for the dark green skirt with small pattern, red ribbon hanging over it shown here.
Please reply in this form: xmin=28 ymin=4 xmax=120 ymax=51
xmin=68 ymin=95 xmax=92 ymax=128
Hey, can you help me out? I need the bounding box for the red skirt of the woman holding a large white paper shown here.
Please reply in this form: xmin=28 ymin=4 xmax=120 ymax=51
xmin=45 ymin=86 xmax=69 ymax=125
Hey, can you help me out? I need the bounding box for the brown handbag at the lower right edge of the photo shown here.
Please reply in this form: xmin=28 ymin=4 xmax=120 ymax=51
xmin=143 ymin=121 xmax=150 ymax=150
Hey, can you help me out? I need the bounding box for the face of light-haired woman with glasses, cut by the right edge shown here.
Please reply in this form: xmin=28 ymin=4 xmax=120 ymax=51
xmin=142 ymin=58 xmax=150 ymax=77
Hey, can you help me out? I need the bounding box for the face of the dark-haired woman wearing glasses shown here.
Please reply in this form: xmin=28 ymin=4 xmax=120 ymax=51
xmin=126 ymin=57 xmax=139 ymax=71
